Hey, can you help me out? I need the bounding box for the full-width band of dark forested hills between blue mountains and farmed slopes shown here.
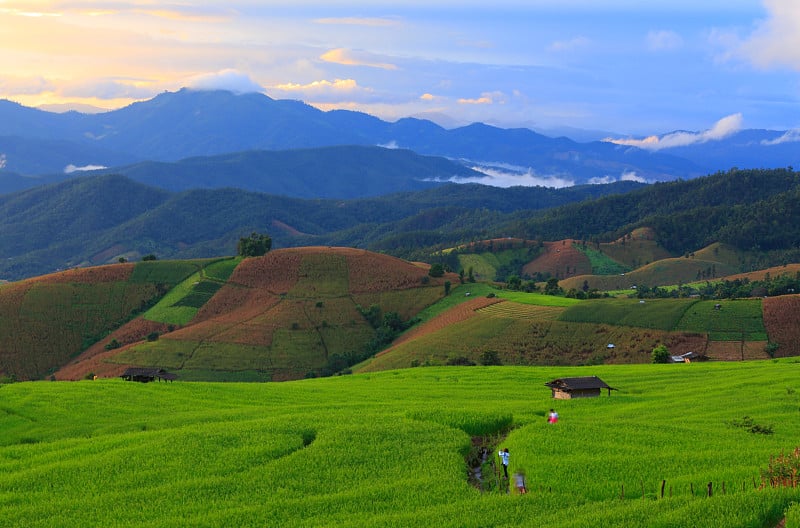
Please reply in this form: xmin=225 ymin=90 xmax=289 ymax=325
xmin=0 ymin=169 xmax=800 ymax=280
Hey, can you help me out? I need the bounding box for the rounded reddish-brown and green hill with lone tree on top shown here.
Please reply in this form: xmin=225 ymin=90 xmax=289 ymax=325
xmin=106 ymin=247 xmax=455 ymax=381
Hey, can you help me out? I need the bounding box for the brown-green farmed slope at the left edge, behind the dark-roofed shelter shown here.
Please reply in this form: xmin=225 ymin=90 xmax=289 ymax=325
xmin=0 ymin=260 xmax=217 ymax=380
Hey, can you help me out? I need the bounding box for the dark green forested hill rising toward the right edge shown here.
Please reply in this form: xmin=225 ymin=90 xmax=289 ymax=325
xmin=503 ymin=168 xmax=800 ymax=254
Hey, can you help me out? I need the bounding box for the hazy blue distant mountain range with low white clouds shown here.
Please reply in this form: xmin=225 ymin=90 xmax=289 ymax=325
xmin=0 ymin=89 xmax=800 ymax=199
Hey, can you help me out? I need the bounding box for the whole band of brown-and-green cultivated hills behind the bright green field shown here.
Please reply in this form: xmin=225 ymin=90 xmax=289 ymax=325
xmin=0 ymin=244 xmax=800 ymax=381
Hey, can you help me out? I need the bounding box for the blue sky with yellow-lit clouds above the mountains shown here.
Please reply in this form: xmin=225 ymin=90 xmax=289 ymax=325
xmin=0 ymin=0 xmax=800 ymax=138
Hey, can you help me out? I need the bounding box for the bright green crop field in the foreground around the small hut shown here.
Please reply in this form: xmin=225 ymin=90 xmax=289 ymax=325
xmin=0 ymin=359 xmax=800 ymax=527
